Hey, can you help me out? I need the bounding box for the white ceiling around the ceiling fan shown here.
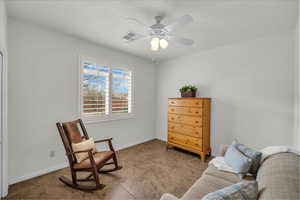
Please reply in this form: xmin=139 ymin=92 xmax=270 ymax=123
xmin=7 ymin=0 xmax=298 ymax=60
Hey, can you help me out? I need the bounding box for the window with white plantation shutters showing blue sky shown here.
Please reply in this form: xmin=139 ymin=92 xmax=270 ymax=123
xmin=79 ymin=60 xmax=133 ymax=122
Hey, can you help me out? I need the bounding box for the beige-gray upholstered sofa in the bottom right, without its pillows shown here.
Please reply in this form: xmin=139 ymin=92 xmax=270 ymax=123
xmin=161 ymin=153 xmax=300 ymax=200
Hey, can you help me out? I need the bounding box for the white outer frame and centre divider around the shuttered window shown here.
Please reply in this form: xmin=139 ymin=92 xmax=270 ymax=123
xmin=78 ymin=56 xmax=135 ymax=123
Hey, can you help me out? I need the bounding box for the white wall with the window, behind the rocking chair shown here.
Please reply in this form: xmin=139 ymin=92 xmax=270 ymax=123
xmin=8 ymin=18 xmax=155 ymax=183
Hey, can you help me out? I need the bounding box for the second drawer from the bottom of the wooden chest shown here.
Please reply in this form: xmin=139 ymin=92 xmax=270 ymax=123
xmin=168 ymin=122 xmax=202 ymax=138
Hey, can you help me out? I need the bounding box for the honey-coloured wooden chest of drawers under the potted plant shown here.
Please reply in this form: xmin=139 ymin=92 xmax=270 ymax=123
xmin=168 ymin=98 xmax=211 ymax=160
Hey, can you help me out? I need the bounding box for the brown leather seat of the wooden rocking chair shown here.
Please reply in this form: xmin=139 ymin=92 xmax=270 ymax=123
xmin=74 ymin=151 xmax=114 ymax=169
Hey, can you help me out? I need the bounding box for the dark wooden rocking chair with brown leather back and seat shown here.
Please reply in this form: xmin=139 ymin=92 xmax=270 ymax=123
xmin=56 ymin=119 xmax=122 ymax=190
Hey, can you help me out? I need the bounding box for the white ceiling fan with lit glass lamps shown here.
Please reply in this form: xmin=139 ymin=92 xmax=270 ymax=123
xmin=123 ymin=15 xmax=194 ymax=51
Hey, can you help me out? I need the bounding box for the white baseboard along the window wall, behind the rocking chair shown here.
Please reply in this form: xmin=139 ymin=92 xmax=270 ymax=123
xmin=8 ymin=138 xmax=155 ymax=185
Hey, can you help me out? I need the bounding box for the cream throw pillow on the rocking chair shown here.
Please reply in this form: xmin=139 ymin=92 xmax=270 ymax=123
xmin=72 ymin=138 xmax=96 ymax=163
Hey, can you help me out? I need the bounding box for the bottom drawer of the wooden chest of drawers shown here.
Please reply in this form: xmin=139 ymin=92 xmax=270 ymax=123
xmin=168 ymin=132 xmax=202 ymax=150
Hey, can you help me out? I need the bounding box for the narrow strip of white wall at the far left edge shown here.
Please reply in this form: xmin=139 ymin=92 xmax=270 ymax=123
xmin=0 ymin=0 xmax=8 ymax=197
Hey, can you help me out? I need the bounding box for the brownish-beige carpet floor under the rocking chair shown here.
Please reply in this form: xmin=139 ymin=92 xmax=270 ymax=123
xmin=4 ymin=140 xmax=211 ymax=200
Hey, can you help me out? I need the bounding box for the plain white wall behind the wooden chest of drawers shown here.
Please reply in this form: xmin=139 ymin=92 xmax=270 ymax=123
xmin=156 ymin=30 xmax=295 ymax=154
